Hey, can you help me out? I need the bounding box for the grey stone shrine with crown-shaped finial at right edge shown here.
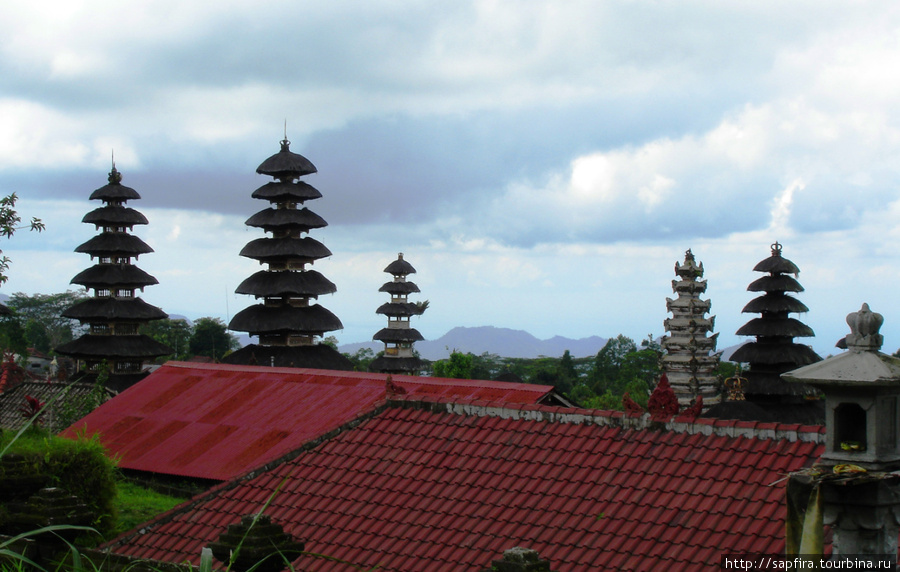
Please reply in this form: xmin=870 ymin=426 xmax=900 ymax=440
xmin=782 ymin=304 xmax=900 ymax=564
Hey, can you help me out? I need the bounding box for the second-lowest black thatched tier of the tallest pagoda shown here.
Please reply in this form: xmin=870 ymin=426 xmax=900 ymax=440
xmin=228 ymin=304 xmax=344 ymax=336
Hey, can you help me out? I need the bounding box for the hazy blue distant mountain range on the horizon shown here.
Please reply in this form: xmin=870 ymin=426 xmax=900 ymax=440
xmin=338 ymin=326 xmax=606 ymax=360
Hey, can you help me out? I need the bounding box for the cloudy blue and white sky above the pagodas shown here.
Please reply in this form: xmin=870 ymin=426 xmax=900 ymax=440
xmin=0 ymin=0 xmax=900 ymax=357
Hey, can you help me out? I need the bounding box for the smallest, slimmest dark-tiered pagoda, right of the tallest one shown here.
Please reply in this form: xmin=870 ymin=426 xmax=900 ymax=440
xmin=369 ymin=252 xmax=428 ymax=375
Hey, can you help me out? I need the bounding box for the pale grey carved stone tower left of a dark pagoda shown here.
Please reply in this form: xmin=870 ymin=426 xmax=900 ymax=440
xmin=662 ymin=250 xmax=720 ymax=408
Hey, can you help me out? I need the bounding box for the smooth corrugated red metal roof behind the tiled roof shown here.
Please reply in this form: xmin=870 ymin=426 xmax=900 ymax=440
xmin=65 ymin=362 xmax=553 ymax=480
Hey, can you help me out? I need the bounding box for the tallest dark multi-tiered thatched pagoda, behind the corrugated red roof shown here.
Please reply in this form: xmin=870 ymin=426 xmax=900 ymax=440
xmin=224 ymin=139 xmax=353 ymax=370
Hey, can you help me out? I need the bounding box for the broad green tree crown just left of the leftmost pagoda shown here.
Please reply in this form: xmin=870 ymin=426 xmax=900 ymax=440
xmin=7 ymin=290 xmax=88 ymax=352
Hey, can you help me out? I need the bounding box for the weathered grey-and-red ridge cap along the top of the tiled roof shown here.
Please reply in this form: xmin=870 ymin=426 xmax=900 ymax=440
xmin=387 ymin=395 xmax=825 ymax=445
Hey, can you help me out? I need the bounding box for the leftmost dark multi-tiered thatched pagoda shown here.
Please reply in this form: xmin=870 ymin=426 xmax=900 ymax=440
xmin=56 ymin=164 xmax=172 ymax=390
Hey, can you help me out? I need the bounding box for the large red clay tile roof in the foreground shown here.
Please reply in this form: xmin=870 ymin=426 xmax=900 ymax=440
xmin=107 ymin=399 xmax=824 ymax=572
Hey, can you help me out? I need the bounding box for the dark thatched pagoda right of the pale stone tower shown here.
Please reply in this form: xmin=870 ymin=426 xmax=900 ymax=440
xmin=731 ymin=242 xmax=824 ymax=424
